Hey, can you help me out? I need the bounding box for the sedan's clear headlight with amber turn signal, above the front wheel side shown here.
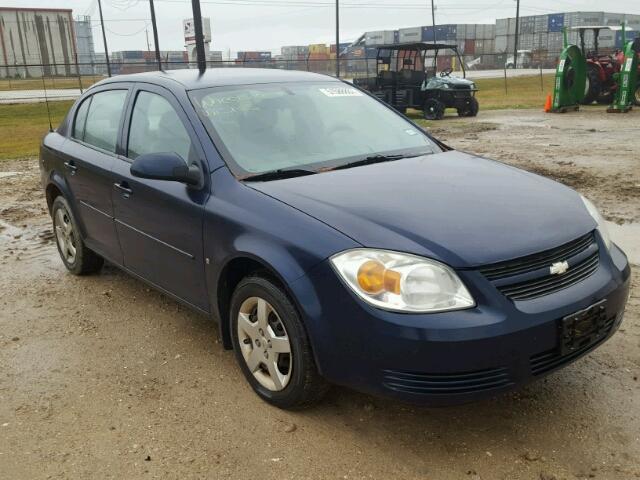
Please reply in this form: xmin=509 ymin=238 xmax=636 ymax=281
xmin=331 ymin=248 xmax=475 ymax=312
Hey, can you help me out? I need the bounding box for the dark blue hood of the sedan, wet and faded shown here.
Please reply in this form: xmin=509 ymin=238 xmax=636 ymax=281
xmin=249 ymin=151 xmax=596 ymax=268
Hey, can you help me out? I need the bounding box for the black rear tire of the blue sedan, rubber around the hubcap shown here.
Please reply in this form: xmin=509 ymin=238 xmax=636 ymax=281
xmin=51 ymin=196 xmax=104 ymax=275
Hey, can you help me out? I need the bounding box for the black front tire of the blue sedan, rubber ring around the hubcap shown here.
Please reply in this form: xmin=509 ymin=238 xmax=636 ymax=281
xmin=229 ymin=275 xmax=329 ymax=409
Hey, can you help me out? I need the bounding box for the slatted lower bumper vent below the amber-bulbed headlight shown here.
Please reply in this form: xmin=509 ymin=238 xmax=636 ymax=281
xmin=383 ymin=368 xmax=513 ymax=395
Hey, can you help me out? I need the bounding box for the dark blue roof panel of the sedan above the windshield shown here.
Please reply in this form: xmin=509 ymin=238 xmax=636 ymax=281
xmin=99 ymin=67 xmax=338 ymax=90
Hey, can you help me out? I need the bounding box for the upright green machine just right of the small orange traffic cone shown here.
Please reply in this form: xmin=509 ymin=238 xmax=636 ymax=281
xmin=551 ymin=28 xmax=587 ymax=113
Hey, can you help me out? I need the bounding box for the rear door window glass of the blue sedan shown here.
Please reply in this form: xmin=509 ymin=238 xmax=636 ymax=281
xmin=84 ymin=90 xmax=127 ymax=153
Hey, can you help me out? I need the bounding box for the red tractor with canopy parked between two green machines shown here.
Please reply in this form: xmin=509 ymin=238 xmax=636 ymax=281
xmin=572 ymin=26 xmax=640 ymax=105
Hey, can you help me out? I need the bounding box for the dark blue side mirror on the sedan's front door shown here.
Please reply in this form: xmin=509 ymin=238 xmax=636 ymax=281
xmin=131 ymin=153 xmax=202 ymax=185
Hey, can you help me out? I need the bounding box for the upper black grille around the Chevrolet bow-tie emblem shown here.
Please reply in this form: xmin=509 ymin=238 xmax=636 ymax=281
xmin=480 ymin=232 xmax=599 ymax=300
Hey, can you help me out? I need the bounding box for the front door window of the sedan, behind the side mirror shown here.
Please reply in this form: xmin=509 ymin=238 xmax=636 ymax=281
xmin=127 ymin=92 xmax=195 ymax=161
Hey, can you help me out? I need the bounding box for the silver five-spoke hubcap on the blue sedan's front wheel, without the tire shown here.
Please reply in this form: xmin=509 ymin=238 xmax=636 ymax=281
xmin=237 ymin=297 xmax=293 ymax=392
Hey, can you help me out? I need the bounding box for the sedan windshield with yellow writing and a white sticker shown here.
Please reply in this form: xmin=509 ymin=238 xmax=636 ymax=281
xmin=189 ymin=82 xmax=440 ymax=176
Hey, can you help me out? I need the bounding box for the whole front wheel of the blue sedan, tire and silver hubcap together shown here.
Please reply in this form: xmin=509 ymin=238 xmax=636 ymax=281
xmin=230 ymin=276 xmax=328 ymax=409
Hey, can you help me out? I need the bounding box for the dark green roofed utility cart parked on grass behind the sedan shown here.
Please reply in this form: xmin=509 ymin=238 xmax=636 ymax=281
xmin=354 ymin=42 xmax=479 ymax=120
